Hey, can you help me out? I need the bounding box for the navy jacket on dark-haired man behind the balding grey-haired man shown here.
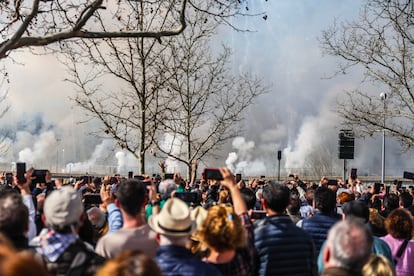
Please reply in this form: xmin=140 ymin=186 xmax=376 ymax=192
xmin=302 ymin=211 xmax=342 ymax=255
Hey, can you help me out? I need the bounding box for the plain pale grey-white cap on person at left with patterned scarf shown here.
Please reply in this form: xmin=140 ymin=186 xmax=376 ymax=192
xmin=43 ymin=186 xmax=83 ymax=227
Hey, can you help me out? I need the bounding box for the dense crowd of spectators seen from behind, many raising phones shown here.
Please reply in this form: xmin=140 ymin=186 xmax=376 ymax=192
xmin=0 ymin=163 xmax=414 ymax=276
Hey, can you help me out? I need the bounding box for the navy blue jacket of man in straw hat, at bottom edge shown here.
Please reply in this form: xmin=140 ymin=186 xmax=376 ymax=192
xmin=155 ymin=245 xmax=221 ymax=276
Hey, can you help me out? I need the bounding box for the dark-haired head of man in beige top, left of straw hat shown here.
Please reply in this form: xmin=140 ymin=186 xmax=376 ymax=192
xmin=116 ymin=179 xmax=147 ymax=216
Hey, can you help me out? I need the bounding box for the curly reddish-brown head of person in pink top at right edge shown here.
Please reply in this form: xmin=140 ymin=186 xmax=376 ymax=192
xmin=385 ymin=208 xmax=414 ymax=240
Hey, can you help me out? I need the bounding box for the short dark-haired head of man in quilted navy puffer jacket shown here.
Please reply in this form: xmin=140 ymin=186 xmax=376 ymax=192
xmin=263 ymin=181 xmax=290 ymax=213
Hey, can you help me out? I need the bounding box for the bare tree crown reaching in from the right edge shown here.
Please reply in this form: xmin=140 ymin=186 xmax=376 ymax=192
xmin=320 ymin=0 xmax=414 ymax=149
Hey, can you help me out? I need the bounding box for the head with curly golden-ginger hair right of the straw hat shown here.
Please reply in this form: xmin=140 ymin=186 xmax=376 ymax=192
xmin=197 ymin=204 xmax=247 ymax=252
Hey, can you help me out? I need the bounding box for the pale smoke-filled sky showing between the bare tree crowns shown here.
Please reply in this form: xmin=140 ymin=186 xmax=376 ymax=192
xmin=2 ymin=0 xmax=406 ymax=175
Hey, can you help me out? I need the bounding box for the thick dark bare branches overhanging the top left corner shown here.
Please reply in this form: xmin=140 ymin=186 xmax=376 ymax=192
xmin=0 ymin=0 xmax=264 ymax=58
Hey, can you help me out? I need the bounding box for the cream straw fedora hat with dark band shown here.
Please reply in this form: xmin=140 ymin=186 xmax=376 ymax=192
xmin=148 ymin=198 xmax=197 ymax=237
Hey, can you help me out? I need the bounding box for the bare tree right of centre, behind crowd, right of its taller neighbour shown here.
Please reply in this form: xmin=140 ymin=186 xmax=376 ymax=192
xmin=155 ymin=10 xmax=267 ymax=177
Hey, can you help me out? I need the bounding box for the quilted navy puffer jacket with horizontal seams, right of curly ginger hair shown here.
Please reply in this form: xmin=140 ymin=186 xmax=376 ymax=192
xmin=254 ymin=215 xmax=317 ymax=275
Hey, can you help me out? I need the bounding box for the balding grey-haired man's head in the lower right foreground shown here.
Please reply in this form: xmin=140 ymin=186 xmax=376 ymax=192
xmin=323 ymin=218 xmax=373 ymax=274
